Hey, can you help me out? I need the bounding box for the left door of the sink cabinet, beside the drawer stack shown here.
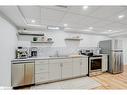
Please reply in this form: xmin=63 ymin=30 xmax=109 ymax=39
xmin=49 ymin=59 xmax=61 ymax=81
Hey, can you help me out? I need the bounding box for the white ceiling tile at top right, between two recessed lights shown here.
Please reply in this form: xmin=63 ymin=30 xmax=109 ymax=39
xmin=90 ymin=6 xmax=126 ymax=19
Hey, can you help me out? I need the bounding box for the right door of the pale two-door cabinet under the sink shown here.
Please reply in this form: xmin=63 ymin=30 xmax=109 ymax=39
xmin=61 ymin=59 xmax=72 ymax=79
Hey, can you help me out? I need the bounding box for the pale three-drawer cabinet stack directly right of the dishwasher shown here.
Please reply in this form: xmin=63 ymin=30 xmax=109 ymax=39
xmin=35 ymin=59 xmax=49 ymax=84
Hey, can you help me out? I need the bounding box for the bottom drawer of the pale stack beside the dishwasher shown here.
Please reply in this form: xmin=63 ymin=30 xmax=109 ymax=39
xmin=35 ymin=73 xmax=48 ymax=83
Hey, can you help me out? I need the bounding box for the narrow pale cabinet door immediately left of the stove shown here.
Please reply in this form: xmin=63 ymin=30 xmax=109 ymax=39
xmin=81 ymin=58 xmax=88 ymax=76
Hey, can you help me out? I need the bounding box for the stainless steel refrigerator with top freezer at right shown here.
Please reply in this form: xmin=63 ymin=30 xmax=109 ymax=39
xmin=99 ymin=39 xmax=123 ymax=74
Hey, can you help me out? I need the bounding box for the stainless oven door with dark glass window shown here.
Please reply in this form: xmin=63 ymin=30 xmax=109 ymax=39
xmin=89 ymin=57 xmax=102 ymax=73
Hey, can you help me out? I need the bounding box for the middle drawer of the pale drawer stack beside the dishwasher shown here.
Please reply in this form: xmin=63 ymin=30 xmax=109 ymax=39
xmin=35 ymin=64 xmax=49 ymax=73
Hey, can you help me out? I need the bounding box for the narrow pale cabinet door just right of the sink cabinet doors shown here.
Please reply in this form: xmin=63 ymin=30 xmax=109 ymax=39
xmin=73 ymin=58 xmax=81 ymax=77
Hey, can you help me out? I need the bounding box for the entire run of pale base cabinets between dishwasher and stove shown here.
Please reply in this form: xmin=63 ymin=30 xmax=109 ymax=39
xmin=35 ymin=57 xmax=88 ymax=84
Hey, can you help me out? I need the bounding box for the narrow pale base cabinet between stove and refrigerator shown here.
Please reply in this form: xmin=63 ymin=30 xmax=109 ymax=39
xmin=102 ymin=54 xmax=108 ymax=72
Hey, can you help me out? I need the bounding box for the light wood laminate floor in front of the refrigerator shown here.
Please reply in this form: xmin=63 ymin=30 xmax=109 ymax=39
xmin=92 ymin=65 xmax=127 ymax=90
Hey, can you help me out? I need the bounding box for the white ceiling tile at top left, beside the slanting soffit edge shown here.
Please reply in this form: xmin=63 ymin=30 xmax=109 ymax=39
xmin=19 ymin=6 xmax=41 ymax=19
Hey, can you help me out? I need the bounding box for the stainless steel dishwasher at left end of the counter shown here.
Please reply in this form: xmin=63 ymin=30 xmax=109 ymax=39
xmin=11 ymin=60 xmax=35 ymax=87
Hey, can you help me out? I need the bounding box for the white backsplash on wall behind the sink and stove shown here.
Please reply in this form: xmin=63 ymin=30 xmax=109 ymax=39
xmin=38 ymin=47 xmax=99 ymax=57
